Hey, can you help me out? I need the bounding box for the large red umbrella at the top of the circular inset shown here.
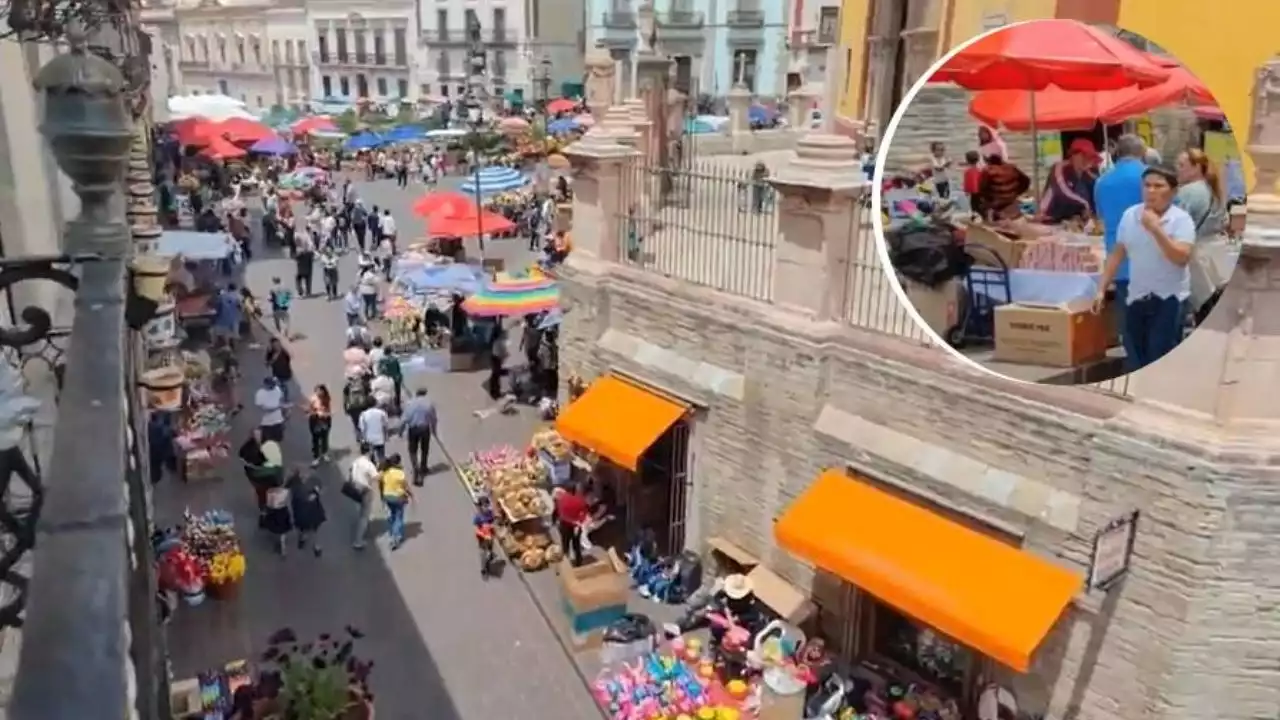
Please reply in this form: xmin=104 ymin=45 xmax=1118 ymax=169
xmin=929 ymin=19 xmax=1169 ymax=91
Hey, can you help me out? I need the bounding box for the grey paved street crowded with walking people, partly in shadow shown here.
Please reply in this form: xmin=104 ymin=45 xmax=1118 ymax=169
xmin=156 ymin=175 xmax=600 ymax=720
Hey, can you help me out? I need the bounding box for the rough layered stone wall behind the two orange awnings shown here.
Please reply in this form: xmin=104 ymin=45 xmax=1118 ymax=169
xmin=562 ymin=248 xmax=1280 ymax=720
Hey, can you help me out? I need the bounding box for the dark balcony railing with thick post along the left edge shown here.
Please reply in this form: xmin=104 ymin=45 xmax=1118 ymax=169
xmin=8 ymin=40 xmax=172 ymax=720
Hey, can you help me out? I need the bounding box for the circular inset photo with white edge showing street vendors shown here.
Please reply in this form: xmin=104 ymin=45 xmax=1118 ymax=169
xmin=874 ymin=19 xmax=1244 ymax=384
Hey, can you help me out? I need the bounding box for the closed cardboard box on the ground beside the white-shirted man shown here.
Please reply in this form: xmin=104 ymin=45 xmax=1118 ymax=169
xmin=995 ymin=300 xmax=1108 ymax=368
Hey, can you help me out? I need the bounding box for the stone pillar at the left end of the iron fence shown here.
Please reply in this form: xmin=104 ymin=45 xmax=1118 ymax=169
xmin=564 ymin=126 xmax=639 ymax=263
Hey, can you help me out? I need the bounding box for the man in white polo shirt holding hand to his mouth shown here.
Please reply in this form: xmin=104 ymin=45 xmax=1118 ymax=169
xmin=1093 ymin=167 xmax=1196 ymax=373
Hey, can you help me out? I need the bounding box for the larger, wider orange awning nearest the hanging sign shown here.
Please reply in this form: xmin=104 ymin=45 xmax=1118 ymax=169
xmin=773 ymin=470 xmax=1083 ymax=673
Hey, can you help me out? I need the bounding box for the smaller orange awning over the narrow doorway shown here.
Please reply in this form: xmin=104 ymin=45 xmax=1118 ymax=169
xmin=556 ymin=375 xmax=689 ymax=470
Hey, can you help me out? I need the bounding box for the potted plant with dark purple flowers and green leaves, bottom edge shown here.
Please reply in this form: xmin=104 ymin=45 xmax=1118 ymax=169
xmin=259 ymin=625 xmax=374 ymax=720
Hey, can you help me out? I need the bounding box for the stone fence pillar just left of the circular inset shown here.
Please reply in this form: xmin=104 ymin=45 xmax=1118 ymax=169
xmin=769 ymin=133 xmax=865 ymax=320
